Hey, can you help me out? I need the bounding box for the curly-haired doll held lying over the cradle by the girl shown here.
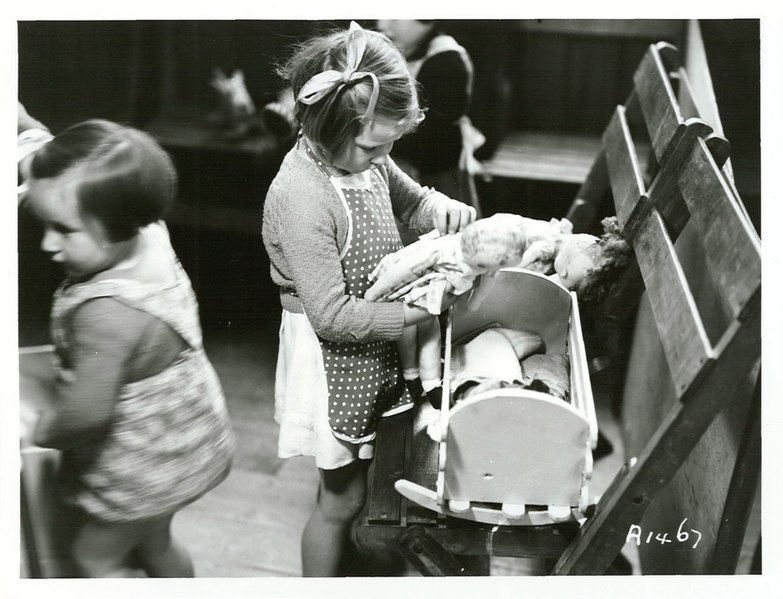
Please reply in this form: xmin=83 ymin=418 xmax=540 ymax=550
xmin=365 ymin=213 xmax=632 ymax=407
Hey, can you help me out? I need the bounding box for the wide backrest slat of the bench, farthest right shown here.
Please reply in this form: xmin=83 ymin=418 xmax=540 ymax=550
xmin=679 ymin=139 xmax=761 ymax=318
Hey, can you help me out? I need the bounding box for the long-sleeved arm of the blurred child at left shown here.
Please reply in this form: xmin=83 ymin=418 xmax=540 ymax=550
xmin=34 ymin=298 xmax=153 ymax=449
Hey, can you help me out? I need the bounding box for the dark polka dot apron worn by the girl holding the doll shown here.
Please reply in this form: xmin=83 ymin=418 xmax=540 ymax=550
xmin=320 ymin=170 xmax=410 ymax=443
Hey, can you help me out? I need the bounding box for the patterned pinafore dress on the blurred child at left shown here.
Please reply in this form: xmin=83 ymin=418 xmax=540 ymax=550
xmin=52 ymin=224 xmax=235 ymax=522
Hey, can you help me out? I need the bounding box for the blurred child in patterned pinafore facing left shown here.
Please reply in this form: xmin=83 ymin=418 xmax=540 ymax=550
xmin=27 ymin=120 xmax=234 ymax=577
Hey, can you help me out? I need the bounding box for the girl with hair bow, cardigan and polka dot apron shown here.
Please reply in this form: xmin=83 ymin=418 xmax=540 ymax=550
xmin=263 ymin=22 xmax=476 ymax=576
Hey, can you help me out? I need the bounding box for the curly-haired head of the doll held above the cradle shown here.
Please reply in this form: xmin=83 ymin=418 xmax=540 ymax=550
xmin=554 ymin=217 xmax=633 ymax=303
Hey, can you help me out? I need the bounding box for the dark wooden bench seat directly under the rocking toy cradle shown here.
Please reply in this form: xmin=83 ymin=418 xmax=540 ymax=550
xmin=357 ymin=407 xmax=579 ymax=576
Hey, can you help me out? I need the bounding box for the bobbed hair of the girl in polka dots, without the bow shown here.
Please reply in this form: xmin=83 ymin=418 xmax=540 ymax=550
xmin=277 ymin=29 xmax=424 ymax=160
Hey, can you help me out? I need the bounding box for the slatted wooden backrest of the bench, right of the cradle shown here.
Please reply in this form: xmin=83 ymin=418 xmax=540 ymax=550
xmin=556 ymin=39 xmax=761 ymax=574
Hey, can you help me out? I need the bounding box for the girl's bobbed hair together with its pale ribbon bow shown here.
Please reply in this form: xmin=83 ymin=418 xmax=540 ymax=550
xmin=279 ymin=23 xmax=423 ymax=163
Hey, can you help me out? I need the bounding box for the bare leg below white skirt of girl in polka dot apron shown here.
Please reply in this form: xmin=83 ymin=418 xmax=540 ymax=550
xmin=302 ymin=460 xmax=369 ymax=576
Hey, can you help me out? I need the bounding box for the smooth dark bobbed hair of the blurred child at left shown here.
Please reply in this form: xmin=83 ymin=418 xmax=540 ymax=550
xmin=31 ymin=119 xmax=177 ymax=241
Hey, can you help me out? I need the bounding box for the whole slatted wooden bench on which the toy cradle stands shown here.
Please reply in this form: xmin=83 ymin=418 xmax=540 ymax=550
xmin=358 ymin=38 xmax=761 ymax=574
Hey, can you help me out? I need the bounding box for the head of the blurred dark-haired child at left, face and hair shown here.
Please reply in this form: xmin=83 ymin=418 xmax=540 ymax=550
xmin=28 ymin=120 xmax=177 ymax=276
